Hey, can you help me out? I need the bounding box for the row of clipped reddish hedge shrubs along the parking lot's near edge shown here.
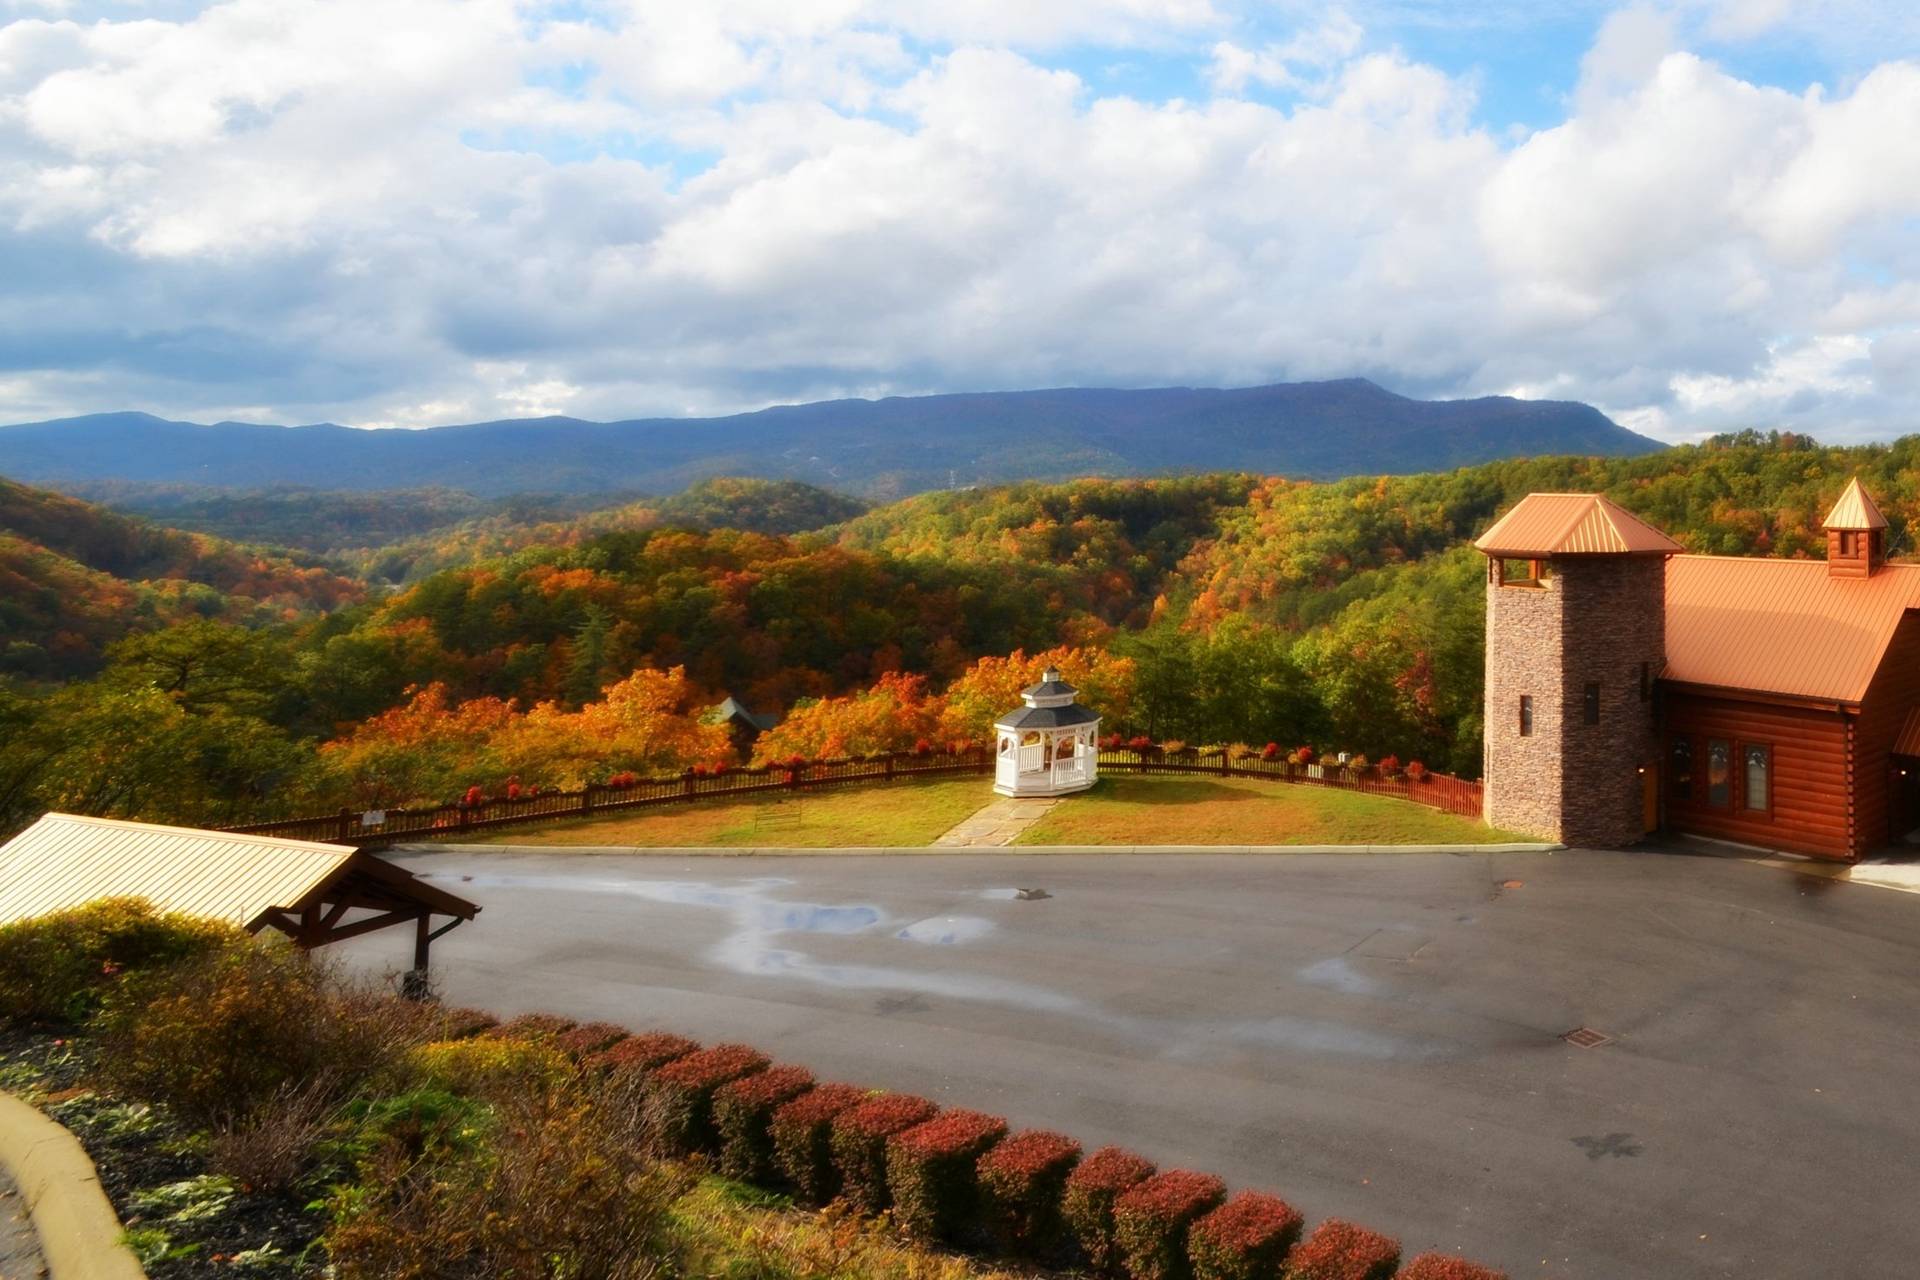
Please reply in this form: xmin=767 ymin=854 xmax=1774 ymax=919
xmin=487 ymin=1009 xmax=1507 ymax=1280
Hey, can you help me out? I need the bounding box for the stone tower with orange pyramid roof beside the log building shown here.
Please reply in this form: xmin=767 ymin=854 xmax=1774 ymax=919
xmin=1475 ymin=493 xmax=1680 ymax=846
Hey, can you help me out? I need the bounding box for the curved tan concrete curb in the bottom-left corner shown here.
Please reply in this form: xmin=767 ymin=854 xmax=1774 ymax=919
xmin=0 ymin=1094 xmax=146 ymax=1280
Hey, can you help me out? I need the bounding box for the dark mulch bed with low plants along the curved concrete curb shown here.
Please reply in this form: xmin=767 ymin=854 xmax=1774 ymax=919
xmin=0 ymin=1027 xmax=326 ymax=1280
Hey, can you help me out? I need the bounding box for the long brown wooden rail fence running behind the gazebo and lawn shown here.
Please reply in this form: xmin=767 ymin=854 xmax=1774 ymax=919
xmin=225 ymin=747 xmax=1480 ymax=848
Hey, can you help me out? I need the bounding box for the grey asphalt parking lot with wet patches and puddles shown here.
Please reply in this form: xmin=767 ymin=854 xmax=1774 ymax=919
xmin=346 ymin=850 xmax=1920 ymax=1280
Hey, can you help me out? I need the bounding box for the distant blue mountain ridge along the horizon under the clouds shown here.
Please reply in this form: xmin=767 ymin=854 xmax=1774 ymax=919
xmin=0 ymin=378 xmax=1663 ymax=499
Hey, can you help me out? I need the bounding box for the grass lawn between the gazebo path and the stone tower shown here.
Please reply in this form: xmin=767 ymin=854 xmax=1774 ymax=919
xmin=1018 ymin=773 xmax=1526 ymax=844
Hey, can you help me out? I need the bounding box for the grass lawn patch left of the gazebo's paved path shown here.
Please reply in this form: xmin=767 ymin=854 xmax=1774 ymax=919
xmin=462 ymin=777 xmax=993 ymax=848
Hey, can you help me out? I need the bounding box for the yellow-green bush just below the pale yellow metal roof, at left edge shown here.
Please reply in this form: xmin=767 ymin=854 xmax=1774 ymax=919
xmin=0 ymin=898 xmax=248 ymax=1023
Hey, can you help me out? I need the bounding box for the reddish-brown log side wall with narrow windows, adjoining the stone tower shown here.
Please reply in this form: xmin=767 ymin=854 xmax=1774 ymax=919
xmin=1661 ymin=689 xmax=1858 ymax=862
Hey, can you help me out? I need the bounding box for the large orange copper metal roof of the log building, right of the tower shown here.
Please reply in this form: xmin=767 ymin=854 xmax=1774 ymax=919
xmin=1665 ymin=555 xmax=1920 ymax=702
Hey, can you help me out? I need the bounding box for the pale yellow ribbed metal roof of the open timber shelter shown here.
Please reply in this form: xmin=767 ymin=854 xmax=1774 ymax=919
xmin=0 ymin=814 xmax=355 ymax=929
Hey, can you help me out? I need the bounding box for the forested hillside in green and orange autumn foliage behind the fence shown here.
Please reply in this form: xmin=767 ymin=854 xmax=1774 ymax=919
xmin=0 ymin=436 xmax=1920 ymax=840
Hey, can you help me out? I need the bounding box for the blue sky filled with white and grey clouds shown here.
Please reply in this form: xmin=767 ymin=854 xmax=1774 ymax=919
xmin=0 ymin=0 xmax=1920 ymax=443
